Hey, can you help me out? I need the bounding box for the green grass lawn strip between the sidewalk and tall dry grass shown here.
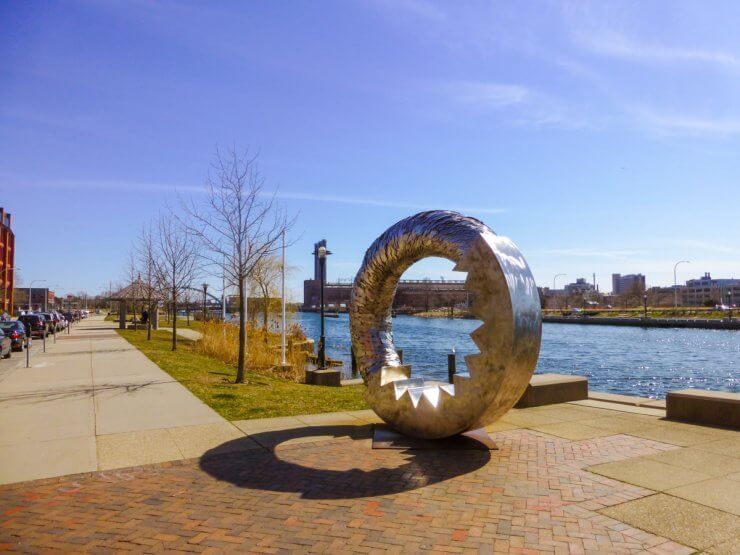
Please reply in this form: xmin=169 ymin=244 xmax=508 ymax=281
xmin=117 ymin=328 xmax=367 ymax=420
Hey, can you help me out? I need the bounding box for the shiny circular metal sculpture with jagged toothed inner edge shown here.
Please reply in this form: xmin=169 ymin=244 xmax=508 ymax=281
xmin=350 ymin=210 xmax=542 ymax=439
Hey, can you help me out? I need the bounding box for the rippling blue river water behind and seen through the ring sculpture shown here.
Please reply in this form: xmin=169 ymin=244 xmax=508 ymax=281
xmin=293 ymin=312 xmax=740 ymax=399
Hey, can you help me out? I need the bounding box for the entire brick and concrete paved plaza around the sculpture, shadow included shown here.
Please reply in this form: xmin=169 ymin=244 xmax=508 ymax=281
xmin=0 ymin=401 xmax=740 ymax=553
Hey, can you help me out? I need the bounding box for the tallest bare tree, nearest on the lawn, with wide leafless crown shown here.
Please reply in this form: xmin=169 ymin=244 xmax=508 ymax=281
xmin=183 ymin=149 xmax=292 ymax=383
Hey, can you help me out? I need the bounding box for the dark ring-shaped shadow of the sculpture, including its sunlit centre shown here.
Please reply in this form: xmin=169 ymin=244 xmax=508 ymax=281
xmin=200 ymin=425 xmax=491 ymax=499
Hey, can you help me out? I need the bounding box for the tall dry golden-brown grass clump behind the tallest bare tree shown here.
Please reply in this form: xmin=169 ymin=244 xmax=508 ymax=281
xmin=196 ymin=320 xmax=306 ymax=382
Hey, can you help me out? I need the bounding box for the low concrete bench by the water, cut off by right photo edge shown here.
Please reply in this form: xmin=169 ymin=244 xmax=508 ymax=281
xmin=666 ymin=389 xmax=740 ymax=430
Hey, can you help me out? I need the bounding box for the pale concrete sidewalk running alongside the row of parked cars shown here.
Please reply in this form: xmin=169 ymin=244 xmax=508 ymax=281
xmin=0 ymin=316 xmax=234 ymax=483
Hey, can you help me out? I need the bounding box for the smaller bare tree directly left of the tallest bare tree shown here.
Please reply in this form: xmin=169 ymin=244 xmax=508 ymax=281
xmin=154 ymin=216 xmax=199 ymax=351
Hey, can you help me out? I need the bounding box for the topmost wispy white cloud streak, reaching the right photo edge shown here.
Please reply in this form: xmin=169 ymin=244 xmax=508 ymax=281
xmin=577 ymin=33 xmax=740 ymax=69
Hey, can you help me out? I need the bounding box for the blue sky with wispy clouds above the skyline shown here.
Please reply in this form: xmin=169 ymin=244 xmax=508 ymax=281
xmin=0 ymin=0 xmax=740 ymax=295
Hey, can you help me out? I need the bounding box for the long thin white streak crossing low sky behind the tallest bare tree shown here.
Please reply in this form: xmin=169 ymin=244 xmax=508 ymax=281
xmin=15 ymin=180 xmax=506 ymax=214
